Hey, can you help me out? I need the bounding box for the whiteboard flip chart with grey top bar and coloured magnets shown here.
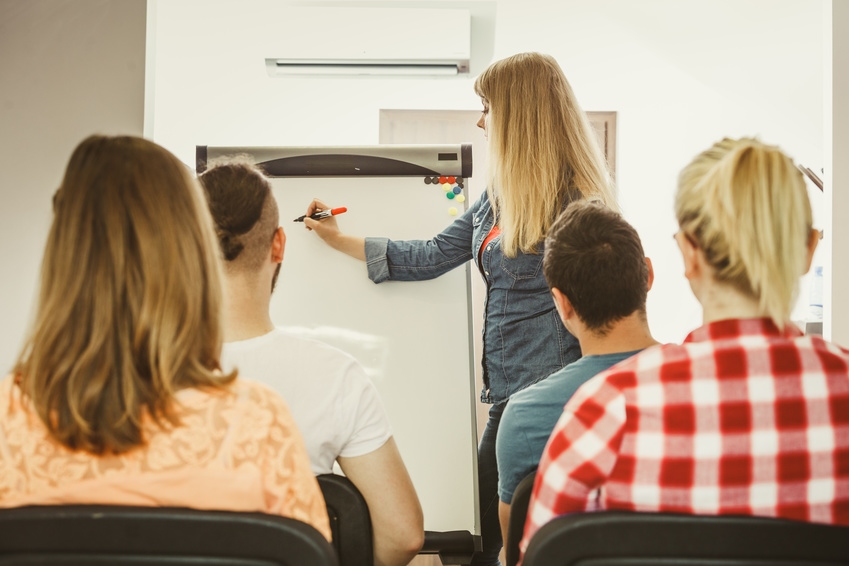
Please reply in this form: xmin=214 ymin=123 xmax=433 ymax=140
xmin=198 ymin=144 xmax=480 ymax=536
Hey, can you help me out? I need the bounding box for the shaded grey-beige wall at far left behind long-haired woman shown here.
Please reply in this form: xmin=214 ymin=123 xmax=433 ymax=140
xmin=0 ymin=0 xmax=146 ymax=375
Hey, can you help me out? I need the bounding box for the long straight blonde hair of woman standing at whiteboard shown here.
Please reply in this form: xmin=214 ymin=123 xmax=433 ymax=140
xmin=475 ymin=53 xmax=618 ymax=257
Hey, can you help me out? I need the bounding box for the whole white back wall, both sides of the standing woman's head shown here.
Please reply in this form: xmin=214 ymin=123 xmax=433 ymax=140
xmin=153 ymin=0 xmax=824 ymax=341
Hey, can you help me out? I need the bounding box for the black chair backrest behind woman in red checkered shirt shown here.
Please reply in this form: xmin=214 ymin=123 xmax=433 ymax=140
xmin=522 ymin=511 xmax=849 ymax=566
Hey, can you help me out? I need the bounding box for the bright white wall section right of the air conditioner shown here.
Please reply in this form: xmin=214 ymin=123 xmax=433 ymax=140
xmin=496 ymin=0 xmax=823 ymax=341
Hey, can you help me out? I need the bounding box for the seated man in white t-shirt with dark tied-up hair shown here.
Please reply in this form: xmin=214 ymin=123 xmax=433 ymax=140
xmin=199 ymin=159 xmax=424 ymax=565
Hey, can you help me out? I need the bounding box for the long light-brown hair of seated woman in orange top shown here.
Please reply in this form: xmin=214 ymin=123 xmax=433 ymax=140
xmin=15 ymin=136 xmax=235 ymax=454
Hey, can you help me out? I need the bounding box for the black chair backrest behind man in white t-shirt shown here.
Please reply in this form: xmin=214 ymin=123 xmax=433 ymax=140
xmin=317 ymin=474 xmax=374 ymax=566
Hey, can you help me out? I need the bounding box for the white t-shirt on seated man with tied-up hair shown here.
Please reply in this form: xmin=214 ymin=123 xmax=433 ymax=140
xmin=221 ymin=328 xmax=392 ymax=474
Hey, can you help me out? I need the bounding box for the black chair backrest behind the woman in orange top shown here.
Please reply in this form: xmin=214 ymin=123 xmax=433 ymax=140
xmin=0 ymin=505 xmax=338 ymax=566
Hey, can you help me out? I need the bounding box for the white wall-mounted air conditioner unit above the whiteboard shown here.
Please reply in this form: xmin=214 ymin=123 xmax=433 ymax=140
xmin=265 ymin=7 xmax=471 ymax=77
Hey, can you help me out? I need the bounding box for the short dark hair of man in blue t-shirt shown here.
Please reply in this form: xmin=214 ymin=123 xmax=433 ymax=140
xmin=543 ymin=200 xmax=649 ymax=335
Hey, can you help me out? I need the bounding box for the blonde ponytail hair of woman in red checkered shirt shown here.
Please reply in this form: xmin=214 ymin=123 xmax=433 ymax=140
xmin=675 ymin=138 xmax=813 ymax=328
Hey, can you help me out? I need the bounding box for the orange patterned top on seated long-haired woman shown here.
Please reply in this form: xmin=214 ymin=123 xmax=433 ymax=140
xmin=0 ymin=377 xmax=330 ymax=540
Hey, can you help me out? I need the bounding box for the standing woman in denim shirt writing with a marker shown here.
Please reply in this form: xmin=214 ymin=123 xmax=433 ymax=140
xmin=304 ymin=53 xmax=617 ymax=565
